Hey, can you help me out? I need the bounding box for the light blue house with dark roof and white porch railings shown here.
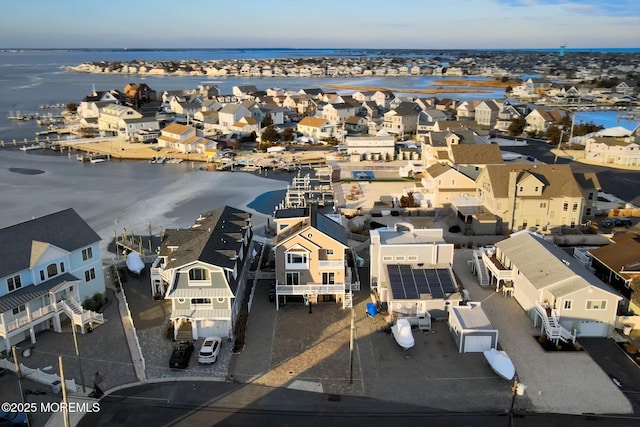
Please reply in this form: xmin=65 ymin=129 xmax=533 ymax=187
xmin=0 ymin=209 xmax=105 ymax=352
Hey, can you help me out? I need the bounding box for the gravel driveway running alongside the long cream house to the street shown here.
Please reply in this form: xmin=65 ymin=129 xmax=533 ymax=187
xmin=454 ymin=249 xmax=633 ymax=414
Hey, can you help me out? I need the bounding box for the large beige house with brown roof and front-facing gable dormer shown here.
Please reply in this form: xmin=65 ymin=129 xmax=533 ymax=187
xmin=476 ymin=164 xmax=584 ymax=233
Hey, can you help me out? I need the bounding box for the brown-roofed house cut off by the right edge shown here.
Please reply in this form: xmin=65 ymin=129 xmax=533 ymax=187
xmin=588 ymin=231 xmax=640 ymax=314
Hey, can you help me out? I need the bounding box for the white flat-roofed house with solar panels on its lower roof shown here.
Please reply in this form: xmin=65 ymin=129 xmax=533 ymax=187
xmin=369 ymin=223 xmax=462 ymax=326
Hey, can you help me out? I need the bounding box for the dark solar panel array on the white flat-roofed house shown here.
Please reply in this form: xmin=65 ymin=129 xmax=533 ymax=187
xmin=387 ymin=264 xmax=456 ymax=299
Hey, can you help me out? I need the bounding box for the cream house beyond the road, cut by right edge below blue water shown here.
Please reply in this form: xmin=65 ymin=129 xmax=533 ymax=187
xmin=584 ymin=137 xmax=640 ymax=167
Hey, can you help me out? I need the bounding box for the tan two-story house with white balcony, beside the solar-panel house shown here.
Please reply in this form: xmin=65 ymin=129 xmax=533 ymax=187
xmin=273 ymin=205 xmax=359 ymax=308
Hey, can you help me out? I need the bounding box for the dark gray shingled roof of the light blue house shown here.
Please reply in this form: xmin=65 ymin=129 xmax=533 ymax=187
xmin=0 ymin=208 xmax=101 ymax=277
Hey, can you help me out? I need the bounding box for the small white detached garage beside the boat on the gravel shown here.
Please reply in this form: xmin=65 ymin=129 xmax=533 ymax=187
xmin=449 ymin=303 xmax=498 ymax=353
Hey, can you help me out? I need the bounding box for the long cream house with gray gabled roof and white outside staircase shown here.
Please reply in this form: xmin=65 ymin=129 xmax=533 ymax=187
xmin=476 ymin=230 xmax=622 ymax=341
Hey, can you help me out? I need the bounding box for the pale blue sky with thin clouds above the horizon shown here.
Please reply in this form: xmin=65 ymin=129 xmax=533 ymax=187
xmin=0 ymin=0 xmax=640 ymax=49
